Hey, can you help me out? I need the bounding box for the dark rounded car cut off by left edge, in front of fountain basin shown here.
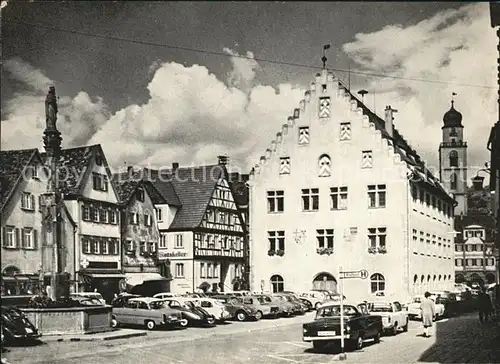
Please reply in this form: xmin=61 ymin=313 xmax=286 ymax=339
xmin=2 ymin=306 xmax=42 ymax=342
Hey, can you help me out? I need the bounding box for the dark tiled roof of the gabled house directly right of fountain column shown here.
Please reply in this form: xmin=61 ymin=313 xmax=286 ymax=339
xmin=41 ymin=144 xmax=118 ymax=198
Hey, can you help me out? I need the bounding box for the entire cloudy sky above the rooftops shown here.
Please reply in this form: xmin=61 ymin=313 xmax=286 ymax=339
xmin=1 ymin=0 xmax=498 ymax=181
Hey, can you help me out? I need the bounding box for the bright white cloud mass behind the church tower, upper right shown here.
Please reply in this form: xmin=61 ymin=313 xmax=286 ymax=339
xmin=344 ymin=3 xmax=497 ymax=177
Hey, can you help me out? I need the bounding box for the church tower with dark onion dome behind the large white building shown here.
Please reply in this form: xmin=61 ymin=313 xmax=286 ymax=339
xmin=439 ymin=100 xmax=467 ymax=216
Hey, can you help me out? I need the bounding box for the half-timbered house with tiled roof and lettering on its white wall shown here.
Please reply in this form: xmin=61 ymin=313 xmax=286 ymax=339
xmin=136 ymin=163 xmax=246 ymax=293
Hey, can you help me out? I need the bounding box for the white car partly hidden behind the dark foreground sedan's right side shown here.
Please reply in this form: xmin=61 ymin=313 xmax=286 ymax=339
xmin=366 ymin=300 xmax=408 ymax=335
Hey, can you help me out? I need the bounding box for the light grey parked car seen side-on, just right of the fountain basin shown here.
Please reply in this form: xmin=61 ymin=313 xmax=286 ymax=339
xmin=111 ymin=297 xmax=185 ymax=330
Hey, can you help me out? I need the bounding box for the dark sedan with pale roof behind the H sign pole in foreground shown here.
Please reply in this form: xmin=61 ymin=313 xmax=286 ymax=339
xmin=302 ymin=302 xmax=383 ymax=350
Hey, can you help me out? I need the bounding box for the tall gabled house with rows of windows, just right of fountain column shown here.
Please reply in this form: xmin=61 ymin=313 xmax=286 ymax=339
xmin=43 ymin=144 xmax=125 ymax=300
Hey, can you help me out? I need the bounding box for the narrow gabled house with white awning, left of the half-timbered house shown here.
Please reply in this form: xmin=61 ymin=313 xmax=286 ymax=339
xmin=113 ymin=173 xmax=170 ymax=295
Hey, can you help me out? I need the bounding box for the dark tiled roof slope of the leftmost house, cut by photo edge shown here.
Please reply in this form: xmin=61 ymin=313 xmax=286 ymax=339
xmin=0 ymin=149 xmax=40 ymax=211
